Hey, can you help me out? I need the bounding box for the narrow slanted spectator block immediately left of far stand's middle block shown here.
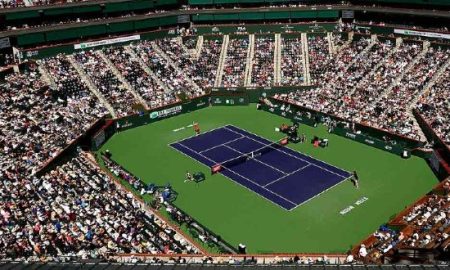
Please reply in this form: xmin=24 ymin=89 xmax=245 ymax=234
xmin=222 ymin=37 xmax=250 ymax=87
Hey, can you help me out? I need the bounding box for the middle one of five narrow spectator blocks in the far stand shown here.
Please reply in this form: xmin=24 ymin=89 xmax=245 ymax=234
xmin=251 ymin=37 xmax=275 ymax=87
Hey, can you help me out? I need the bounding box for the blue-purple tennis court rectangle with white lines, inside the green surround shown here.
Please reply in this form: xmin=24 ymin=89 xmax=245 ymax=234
xmin=171 ymin=125 xmax=351 ymax=210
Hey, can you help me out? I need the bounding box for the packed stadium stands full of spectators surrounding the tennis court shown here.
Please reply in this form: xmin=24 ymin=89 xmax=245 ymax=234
xmin=0 ymin=20 xmax=450 ymax=263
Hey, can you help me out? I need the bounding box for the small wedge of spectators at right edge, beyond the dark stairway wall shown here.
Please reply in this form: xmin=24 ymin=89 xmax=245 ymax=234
xmin=417 ymin=62 xmax=450 ymax=145
